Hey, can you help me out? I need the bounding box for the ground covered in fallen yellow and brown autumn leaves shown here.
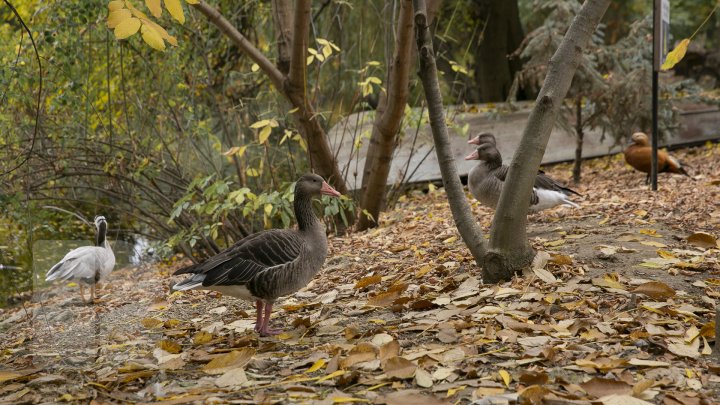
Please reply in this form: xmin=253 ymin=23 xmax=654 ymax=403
xmin=0 ymin=145 xmax=720 ymax=405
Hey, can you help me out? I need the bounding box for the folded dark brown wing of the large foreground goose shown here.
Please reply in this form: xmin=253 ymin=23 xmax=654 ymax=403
xmin=175 ymin=229 xmax=304 ymax=287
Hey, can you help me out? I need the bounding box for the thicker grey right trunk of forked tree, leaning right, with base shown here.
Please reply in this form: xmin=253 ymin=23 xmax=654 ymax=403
xmin=483 ymin=0 xmax=610 ymax=282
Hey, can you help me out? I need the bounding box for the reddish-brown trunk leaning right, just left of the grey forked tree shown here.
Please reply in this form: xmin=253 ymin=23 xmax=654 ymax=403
xmin=358 ymin=0 xmax=413 ymax=230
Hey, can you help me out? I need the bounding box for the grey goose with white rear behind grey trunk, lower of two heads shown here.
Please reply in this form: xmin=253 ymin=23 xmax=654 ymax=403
xmin=465 ymin=143 xmax=580 ymax=211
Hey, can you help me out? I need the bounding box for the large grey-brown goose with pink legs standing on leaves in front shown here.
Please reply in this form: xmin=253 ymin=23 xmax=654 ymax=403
xmin=173 ymin=174 xmax=341 ymax=336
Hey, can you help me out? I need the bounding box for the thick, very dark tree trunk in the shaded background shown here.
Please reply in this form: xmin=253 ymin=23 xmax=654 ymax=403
xmin=474 ymin=0 xmax=523 ymax=102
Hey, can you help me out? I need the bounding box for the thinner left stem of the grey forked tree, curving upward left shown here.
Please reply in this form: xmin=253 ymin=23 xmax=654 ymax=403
xmin=413 ymin=0 xmax=486 ymax=264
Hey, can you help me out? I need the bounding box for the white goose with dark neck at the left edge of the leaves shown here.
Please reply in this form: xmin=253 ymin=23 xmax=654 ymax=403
xmin=45 ymin=215 xmax=115 ymax=302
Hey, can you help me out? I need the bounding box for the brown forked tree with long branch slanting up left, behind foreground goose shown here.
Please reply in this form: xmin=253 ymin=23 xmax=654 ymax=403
xmin=192 ymin=0 xmax=347 ymax=194
